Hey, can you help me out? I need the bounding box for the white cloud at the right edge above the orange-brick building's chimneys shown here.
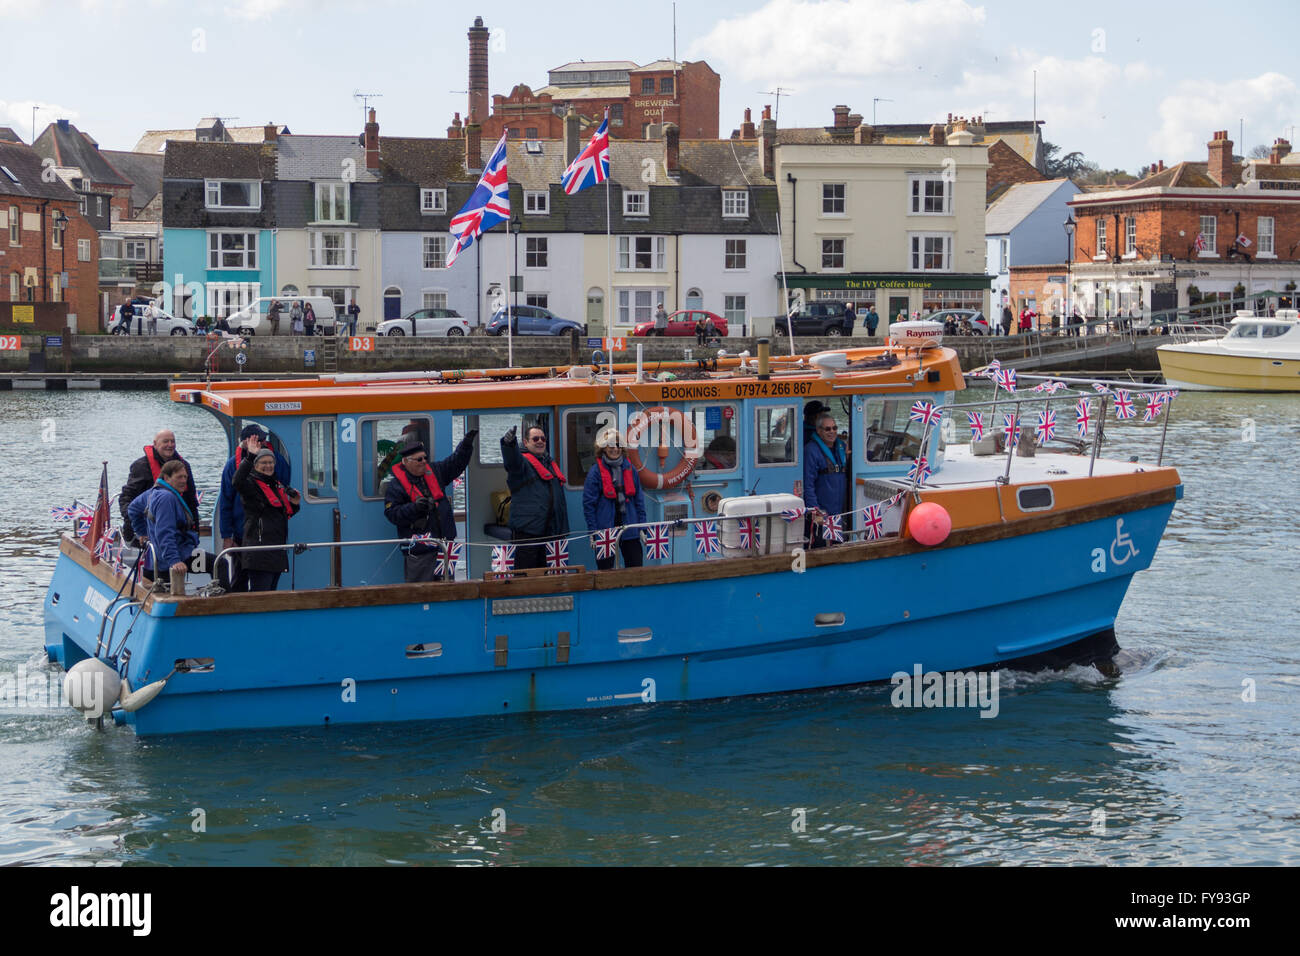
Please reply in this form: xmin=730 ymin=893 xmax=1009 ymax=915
xmin=1147 ymin=73 xmax=1300 ymax=165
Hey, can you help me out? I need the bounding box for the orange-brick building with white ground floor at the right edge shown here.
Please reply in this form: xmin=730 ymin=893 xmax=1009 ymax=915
xmin=1070 ymin=130 xmax=1300 ymax=316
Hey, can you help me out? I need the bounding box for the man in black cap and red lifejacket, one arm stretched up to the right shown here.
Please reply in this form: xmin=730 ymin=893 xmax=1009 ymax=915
xmin=384 ymin=429 xmax=478 ymax=584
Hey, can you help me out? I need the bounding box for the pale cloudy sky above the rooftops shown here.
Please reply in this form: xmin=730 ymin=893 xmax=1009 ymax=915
xmin=0 ymin=0 xmax=1300 ymax=170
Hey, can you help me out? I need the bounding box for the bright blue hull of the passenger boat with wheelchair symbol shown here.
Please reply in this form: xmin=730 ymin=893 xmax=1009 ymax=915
xmin=46 ymin=502 xmax=1173 ymax=735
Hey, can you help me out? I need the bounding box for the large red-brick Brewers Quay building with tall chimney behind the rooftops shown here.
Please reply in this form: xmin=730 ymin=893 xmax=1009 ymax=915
xmin=447 ymin=17 xmax=722 ymax=143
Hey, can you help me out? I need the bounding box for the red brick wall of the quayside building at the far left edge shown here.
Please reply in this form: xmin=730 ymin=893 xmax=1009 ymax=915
xmin=0 ymin=195 xmax=100 ymax=332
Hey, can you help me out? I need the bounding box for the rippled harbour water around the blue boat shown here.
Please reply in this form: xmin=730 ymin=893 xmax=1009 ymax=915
xmin=0 ymin=392 xmax=1300 ymax=865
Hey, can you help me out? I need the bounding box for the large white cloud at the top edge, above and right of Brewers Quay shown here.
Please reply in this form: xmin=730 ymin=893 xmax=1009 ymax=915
xmin=686 ymin=0 xmax=984 ymax=85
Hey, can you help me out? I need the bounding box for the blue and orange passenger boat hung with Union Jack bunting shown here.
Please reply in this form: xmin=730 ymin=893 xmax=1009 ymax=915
xmin=46 ymin=338 xmax=1182 ymax=734
